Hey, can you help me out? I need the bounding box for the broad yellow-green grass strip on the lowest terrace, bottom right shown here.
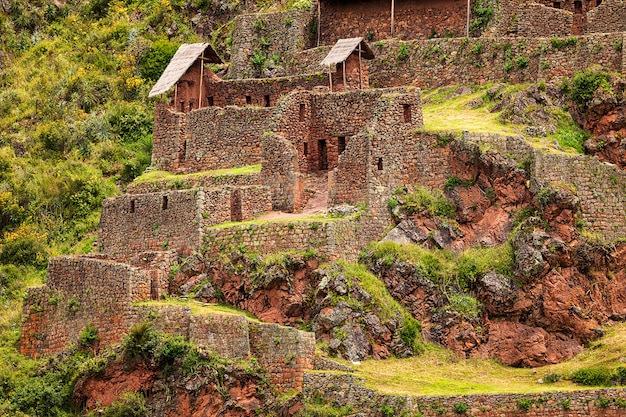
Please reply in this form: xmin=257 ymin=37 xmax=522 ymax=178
xmin=353 ymin=323 xmax=626 ymax=396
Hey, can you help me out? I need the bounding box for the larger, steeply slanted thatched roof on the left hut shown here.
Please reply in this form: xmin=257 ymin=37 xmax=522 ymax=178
xmin=148 ymin=43 xmax=222 ymax=97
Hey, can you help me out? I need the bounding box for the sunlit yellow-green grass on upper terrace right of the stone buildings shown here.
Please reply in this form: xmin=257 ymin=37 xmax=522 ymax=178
xmin=422 ymin=86 xmax=524 ymax=135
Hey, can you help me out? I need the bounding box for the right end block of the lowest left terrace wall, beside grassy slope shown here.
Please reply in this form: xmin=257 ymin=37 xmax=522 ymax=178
xmin=249 ymin=322 xmax=315 ymax=391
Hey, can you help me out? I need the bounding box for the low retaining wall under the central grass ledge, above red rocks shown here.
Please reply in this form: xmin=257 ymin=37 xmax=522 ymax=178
xmin=204 ymin=219 xmax=363 ymax=259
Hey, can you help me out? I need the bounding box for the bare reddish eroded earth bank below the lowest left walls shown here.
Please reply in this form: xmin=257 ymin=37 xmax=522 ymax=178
xmin=73 ymin=354 xmax=302 ymax=417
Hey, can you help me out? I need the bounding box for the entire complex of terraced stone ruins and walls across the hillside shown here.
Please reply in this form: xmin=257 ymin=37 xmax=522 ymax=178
xmin=21 ymin=0 xmax=626 ymax=396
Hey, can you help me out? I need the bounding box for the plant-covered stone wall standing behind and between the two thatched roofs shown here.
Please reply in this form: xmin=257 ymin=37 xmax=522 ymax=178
xmin=227 ymin=10 xmax=314 ymax=79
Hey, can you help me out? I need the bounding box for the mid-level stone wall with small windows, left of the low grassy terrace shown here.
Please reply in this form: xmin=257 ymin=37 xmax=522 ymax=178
xmin=98 ymin=186 xmax=272 ymax=258
